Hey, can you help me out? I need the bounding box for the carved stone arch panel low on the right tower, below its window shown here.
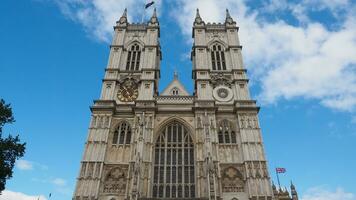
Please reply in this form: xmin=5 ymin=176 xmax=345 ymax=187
xmin=222 ymin=166 xmax=244 ymax=192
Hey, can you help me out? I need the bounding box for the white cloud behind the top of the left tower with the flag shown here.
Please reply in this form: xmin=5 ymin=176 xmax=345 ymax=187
xmin=56 ymin=0 xmax=161 ymax=42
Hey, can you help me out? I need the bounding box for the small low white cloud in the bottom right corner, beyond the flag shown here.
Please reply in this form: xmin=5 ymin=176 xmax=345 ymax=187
xmin=301 ymin=187 xmax=356 ymax=200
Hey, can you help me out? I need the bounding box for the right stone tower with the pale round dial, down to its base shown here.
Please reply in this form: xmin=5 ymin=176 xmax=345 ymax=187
xmin=192 ymin=10 xmax=273 ymax=199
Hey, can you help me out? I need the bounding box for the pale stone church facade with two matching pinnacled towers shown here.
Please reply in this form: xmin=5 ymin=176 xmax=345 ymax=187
xmin=73 ymin=10 xmax=298 ymax=200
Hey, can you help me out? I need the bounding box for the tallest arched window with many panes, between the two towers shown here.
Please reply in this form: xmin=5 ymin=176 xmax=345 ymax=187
xmin=153 ymin=121 xmax=195 ymax=198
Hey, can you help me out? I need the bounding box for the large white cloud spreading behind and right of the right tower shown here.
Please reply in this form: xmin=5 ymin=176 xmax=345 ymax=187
xmin=170 ymin=0 xmax=356 ymax=111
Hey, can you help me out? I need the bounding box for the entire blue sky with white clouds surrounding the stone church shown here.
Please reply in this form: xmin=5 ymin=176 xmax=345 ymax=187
xmin=0 ymin=0 xmax=356 ymax=200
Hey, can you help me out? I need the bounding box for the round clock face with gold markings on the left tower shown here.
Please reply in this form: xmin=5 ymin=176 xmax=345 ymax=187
xmin=117 ymin=80 xmax=138 ymax=102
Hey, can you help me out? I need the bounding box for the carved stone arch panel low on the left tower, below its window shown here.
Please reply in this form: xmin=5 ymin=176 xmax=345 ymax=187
xmin=103 ymin=166 xmax=128 ymax=195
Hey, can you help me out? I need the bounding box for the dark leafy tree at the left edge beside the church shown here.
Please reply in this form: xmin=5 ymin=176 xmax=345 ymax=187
xmin=0 ymin=99 xmax=26 ymax=194
